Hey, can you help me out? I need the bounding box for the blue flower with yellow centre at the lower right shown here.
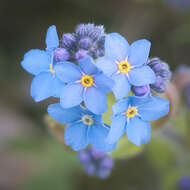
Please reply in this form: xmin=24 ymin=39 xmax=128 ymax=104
xmin=107 ymin=95 xmax=169 ymax=146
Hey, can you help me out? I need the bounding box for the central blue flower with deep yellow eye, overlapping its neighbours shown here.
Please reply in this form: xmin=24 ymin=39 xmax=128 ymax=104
xmin=55 ymin=57 xmax=114 ymax=114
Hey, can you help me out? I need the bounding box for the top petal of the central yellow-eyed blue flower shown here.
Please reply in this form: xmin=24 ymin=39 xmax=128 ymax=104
xmin=78 ymin=56 xmax=99 ymax=75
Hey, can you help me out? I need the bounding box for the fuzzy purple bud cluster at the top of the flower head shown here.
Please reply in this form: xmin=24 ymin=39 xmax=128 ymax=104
xmin=61 ymin=24 xmax=105 ymax=61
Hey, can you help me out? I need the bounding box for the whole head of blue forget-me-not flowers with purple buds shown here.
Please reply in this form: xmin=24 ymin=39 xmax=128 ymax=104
xmin=21 ymin=24 xmax=169 ymax=152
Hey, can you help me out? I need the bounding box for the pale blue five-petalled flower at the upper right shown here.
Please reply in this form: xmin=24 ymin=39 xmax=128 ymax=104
xmin=96 ymin=33 xmax=156 ymax=99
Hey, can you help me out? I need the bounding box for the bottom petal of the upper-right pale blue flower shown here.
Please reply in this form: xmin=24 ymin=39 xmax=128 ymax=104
xmin=112 ymin=74 xmax=131 ymax=100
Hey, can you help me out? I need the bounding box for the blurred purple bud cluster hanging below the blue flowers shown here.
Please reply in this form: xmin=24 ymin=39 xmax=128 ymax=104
xmin=78 ymin=147 xmax=114 ymax=179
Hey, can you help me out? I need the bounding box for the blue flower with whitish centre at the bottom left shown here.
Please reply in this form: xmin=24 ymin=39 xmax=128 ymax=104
xmin=48 ymin=104 xmax=116 ymax=152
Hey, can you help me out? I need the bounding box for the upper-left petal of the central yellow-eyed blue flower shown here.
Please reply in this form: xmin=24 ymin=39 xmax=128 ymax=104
xmin=54 ymin=62 xmax=82 ymax=82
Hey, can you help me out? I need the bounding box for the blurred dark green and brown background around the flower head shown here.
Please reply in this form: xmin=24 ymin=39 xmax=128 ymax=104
xmin=0 ymin=0 xmax=190 ymax=190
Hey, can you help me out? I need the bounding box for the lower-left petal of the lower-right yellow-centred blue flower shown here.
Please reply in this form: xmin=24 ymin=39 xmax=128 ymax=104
xmin=106 ymin=115 xmax=127 ymax=144
